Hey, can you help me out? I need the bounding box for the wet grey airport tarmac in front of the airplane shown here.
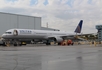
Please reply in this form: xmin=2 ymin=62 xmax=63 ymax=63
xmin=0 ymin=45 xmax=102 ymax=70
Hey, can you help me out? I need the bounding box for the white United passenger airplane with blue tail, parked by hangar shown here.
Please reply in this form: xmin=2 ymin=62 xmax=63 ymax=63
xmin=2 ymin=20 xmax=83 ymax=46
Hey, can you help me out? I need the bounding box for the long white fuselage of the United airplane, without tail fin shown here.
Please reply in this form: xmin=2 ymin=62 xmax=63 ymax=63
xmin=2 ymin=29 xmax=75 ymax=39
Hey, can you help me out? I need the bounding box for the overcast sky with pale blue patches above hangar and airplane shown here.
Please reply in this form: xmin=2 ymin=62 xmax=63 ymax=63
xmin=0 ymin=0 xmax=102 ymax=33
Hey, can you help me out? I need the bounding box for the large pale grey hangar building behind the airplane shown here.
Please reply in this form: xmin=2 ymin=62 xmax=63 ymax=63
xmin=0 ymin=12 xmax=57 ymax=36
